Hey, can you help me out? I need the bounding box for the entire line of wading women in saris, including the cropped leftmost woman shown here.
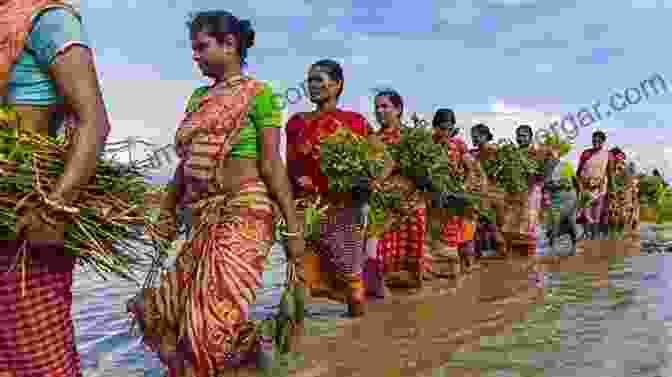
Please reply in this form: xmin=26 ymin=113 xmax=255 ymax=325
xmin=0 ymin=0 xmax=640 ymax=377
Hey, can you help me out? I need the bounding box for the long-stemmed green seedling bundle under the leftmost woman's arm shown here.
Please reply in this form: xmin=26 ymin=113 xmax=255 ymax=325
xmin=0 ymin=128 xmax=161 ymax=281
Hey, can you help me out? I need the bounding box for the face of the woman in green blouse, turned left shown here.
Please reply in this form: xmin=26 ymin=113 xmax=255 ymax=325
xmin=191 ymin=31 xmax=240 ymax=77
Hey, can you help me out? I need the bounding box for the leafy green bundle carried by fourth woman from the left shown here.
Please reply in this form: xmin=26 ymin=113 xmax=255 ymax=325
xmin=388 ymin=126 xmax=465 ymax=193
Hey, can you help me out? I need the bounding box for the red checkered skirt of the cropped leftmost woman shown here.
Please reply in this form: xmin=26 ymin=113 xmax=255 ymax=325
xmin=0 ymin=241 xmax=81 ymax=377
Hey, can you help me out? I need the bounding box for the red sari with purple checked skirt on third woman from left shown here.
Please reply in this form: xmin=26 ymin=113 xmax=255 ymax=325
xmin=287 ymin=110 xmax=369 ymax=305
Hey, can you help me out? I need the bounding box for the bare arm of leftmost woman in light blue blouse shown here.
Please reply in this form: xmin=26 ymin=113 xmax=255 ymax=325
xmin=49 ymin=46 xmax=110 ymax=200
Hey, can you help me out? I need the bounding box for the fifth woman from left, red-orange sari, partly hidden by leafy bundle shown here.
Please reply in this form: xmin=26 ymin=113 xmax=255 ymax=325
xmin=432 ymin=109 xmax=478 ymax=270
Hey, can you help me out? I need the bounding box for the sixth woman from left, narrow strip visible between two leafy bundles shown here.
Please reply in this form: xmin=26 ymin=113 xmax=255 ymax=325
xmin=465 ymin=123 xmax=500 ymax=257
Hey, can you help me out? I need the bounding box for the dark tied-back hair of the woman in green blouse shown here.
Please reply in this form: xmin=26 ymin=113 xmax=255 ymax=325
xmin=187 ymin=10 xmax=255 ymax=66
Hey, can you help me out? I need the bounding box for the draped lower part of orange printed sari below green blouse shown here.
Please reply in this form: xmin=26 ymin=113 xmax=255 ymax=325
xmin=134 ymin=181 xmax=274 ymax=377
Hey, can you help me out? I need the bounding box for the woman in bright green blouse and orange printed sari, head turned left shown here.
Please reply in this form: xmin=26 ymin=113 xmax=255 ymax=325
xmin=128 ymin=11 xmax=304 ymax=376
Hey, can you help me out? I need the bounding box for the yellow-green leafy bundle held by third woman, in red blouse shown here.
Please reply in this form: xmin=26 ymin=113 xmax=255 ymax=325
xmin=320 ymin=128 xmax=385 ymax=192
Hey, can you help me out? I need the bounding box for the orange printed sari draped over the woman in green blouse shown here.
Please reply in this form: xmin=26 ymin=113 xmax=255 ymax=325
xmin=129 ymin=76 xmax=278 ymax=377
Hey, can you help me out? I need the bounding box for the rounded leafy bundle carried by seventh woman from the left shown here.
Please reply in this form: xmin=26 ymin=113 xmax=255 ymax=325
xmin=481 ymin=139 xmax=543 ymax=193
